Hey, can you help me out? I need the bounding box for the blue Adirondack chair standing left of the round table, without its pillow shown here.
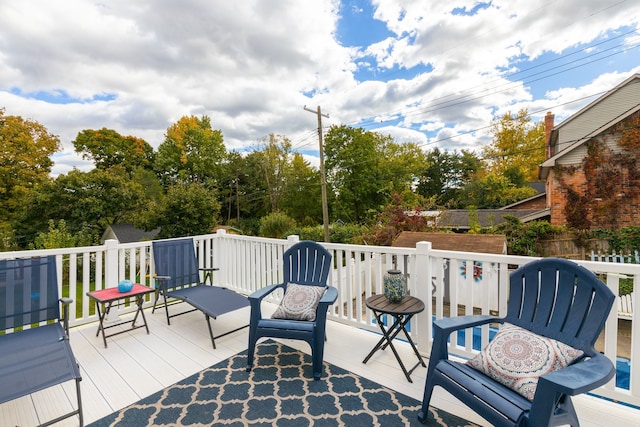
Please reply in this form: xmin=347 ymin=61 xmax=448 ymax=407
xmin=247 ymin=241 xmax=338 ymax=380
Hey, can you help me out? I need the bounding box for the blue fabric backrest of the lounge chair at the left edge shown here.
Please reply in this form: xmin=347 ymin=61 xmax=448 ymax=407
xmin=0 ymin=255 xmax=60 ymax=330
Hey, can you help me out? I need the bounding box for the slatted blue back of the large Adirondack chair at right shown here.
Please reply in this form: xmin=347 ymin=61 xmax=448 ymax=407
xmin=505 ymin=258 xmax=615 ymax=354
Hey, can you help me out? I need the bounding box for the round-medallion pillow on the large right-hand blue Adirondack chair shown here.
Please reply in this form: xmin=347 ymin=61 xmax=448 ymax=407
xmin=467 ymin=323 xmax=583 ymax=400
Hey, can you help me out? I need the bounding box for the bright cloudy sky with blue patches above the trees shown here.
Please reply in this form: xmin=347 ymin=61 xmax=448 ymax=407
xmin=0 ymin=0 xmax=640 ymax=174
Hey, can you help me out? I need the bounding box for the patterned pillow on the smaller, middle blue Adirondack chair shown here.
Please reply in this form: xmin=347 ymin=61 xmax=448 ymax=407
xmin=271 ymin=283 xmax=327 ymax=321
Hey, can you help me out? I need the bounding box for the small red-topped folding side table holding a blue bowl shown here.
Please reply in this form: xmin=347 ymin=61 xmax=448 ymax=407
xmin=87 ymin=283 xmax=155 ymax=348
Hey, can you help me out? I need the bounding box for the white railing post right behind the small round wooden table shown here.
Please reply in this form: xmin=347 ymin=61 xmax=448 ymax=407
xmin=415 ymin=242 xmax=433 ymax=356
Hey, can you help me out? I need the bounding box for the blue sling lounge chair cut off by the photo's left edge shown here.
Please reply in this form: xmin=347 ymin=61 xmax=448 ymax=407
xmin=0 ymin=256 xmax=83 ymax=426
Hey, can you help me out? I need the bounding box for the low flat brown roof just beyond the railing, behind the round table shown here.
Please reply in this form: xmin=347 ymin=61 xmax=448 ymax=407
xmin=391 ymin=231 xmax=507 ymax=254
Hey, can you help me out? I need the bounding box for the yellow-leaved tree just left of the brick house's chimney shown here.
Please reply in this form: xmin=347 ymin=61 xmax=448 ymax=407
xmin=482 ymin=110 xmax=545 ymax=182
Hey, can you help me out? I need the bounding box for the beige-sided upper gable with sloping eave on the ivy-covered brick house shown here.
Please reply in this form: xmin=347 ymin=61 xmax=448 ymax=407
xmin=539 ymin=74 xmax=640 ymax=179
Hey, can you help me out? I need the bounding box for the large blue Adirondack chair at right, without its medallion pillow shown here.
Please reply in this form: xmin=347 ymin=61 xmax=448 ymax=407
xmin=418 ymin=258 xmax=615 ymax=426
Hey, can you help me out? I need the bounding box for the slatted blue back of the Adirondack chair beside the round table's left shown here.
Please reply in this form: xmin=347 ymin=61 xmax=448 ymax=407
xmin=283 ymin=240 xmax=332 ymax=286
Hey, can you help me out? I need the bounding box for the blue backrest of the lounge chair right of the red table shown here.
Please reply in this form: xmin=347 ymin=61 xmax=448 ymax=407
xmin=153 ymin=238 xmax=200 ymax=289
